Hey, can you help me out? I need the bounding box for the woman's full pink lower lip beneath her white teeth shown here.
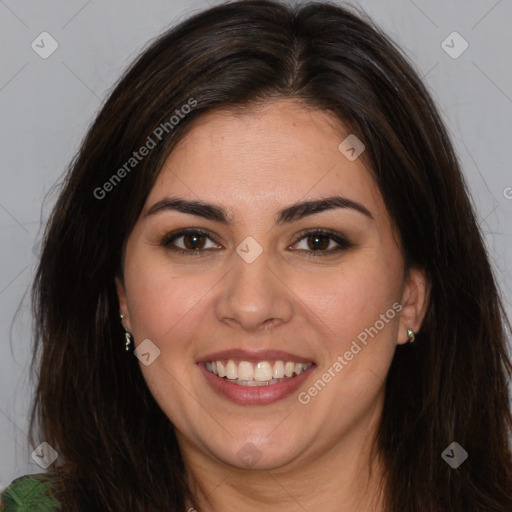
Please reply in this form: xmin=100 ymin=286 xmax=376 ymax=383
xmin=198 ymin=363 xmax=315 ymax=405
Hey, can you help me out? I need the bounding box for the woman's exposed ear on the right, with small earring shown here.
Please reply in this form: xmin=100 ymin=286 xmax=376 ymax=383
xmin=397 ymin=267 xmax=430 ymax=345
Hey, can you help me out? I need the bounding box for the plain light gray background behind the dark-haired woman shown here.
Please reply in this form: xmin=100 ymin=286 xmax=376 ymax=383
xmin=0 ymin=0 xmax=512 ymax=488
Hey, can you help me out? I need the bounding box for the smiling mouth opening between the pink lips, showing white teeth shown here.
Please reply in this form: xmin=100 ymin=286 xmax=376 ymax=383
xmin=204 ymin=359 xmax=313 ymax=387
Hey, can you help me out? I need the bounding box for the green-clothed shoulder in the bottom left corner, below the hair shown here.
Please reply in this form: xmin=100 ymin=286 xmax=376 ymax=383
xmin=0 ymin=472 xmax=62 ymax=512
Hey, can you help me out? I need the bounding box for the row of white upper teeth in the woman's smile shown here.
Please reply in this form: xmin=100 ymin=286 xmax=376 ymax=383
xmin=206 ymin=359 xmax=313 ymax=382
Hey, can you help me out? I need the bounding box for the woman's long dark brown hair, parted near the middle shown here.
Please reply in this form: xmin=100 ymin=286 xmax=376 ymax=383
xmin=30 ymin=0 xmax=512 ymax=512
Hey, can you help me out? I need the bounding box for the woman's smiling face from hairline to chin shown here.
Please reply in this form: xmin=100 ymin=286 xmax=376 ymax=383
xmin=118 ymin=100 xmax=424 ymax=476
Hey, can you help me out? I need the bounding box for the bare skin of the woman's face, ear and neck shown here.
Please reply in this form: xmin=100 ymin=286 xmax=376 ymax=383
xmin=117 ymin=100 xmax=428 ymax=512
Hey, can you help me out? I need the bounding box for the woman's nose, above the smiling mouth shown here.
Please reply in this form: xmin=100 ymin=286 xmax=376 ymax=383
xmin=215 ymin=247 xmax=294 ymax=332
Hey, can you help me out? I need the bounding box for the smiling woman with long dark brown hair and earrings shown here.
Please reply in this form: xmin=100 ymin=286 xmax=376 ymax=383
xmin=3 ymin=0 xmax=512 ymax=512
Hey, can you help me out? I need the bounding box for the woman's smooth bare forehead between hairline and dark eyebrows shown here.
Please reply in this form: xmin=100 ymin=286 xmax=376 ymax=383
xmin=147 ymin=100 xmax=384 ymax=222
